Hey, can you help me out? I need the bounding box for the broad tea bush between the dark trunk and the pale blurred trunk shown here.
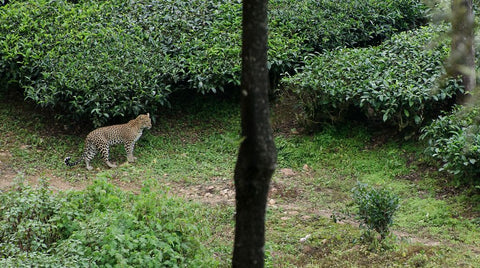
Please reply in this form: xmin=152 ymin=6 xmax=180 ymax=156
xmin=284 ymin=26 xmax=461 ymax=129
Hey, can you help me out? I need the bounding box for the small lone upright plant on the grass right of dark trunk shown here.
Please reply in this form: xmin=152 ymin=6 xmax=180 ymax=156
xmin=352 ymin=183 xmax=399 ymax=240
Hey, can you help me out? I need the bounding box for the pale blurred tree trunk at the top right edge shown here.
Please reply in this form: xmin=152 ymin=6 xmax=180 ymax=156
xmin=450 ymin=0 xmax=476 ymax=104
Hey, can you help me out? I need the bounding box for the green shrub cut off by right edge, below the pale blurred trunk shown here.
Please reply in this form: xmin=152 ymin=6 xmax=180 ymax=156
xmin=421 ymin=106 xmax=480 ymax=183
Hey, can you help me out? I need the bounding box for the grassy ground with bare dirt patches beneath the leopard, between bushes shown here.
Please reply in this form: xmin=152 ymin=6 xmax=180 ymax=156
xmin=0 ymin=93 xmax=480 ymax=267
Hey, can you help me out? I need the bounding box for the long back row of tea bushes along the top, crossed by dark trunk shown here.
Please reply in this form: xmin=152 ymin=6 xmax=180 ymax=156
xmin=0 ymin=0 xmax=425 ymax=125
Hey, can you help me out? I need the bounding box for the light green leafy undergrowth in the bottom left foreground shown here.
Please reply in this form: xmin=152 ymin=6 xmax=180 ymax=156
xmin=0 ymin=180 xmax=214 ymax=267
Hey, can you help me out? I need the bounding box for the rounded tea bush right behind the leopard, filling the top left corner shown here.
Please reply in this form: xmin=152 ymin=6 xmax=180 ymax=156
xmin=0 ymin=0 xmax=176 ymax=126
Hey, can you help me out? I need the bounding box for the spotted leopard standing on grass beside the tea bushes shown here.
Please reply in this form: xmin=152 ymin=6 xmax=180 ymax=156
xmin=64 ymin=113 xmax=152 ymax=170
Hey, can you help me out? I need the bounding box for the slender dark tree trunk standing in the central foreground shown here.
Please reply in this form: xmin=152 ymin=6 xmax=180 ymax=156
xmin=232 ymin=0 xmax=276 ymax=267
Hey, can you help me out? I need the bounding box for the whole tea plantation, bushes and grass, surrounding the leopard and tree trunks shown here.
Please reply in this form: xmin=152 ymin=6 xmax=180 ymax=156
xmin=0 ymin=0 xmax=480 ymax=267
